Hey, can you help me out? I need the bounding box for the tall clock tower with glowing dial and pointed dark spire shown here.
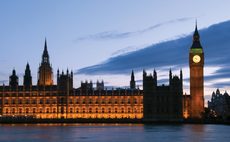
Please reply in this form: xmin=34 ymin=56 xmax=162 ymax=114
xmin=189 ymin=24 xmax=204 ymax=119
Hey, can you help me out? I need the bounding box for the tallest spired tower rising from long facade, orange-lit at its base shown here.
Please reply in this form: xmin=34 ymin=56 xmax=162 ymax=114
xmin=38 ymin=39 xmax=53 ymax=86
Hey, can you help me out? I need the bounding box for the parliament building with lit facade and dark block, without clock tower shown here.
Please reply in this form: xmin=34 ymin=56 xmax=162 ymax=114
xmin=0 ymin=41 xmax=182 ymax=120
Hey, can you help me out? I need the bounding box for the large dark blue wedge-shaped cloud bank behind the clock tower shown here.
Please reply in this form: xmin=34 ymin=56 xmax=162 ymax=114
xmin=77 ymin=21 xmax=230 ymax=86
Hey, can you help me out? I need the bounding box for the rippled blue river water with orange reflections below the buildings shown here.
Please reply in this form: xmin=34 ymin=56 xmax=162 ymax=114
xmin=0 ymin=124 xmax=230 ymax=142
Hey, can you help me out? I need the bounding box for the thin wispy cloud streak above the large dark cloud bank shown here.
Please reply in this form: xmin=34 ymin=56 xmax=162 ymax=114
xmin=75 ymin=17 xmax=194 ymax=42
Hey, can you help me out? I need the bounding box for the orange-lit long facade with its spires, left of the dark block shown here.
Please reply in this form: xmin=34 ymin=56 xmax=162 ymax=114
xmin=0 ymin=41 xmax=143 ymax=119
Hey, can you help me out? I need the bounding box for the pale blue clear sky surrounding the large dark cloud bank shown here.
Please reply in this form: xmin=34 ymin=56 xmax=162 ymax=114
xmin=0 ymin=0 xmax=230 ymax=102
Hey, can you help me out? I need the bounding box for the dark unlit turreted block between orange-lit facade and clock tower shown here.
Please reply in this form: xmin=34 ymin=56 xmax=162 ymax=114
xmin=143 ymin=70 xmax=183 ymax=121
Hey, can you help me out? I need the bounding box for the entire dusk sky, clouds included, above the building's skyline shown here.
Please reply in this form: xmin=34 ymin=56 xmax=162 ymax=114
xmin=0 ymin=0 xmax=230 ymax=102
